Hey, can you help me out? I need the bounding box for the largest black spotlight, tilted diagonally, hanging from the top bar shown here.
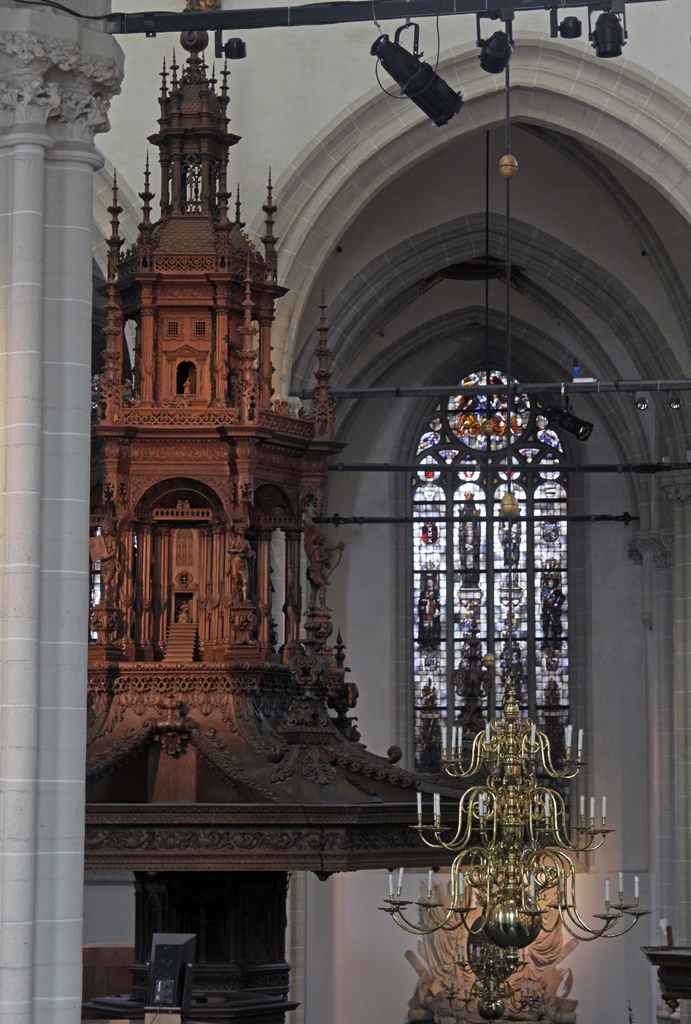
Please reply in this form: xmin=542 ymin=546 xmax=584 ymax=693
xmin=370 ymin=25 xmax=463 ymax=128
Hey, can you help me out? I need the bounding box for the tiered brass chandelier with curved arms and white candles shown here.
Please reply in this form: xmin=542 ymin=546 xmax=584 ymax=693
xmin=383 ymin=676 xmax=649 ymax=1020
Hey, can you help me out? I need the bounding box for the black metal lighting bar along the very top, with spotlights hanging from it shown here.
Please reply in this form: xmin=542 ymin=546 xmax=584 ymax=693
xmin=105 ymin=0 xmax=664 ymax=36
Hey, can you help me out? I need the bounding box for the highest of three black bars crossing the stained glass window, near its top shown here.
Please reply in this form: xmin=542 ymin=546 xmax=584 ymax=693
xmin=291 ymin=377 xmax=691 ymax=399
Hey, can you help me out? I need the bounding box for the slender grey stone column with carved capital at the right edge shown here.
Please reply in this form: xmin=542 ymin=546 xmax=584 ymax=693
xmin=659 ymin=471 xmax=691 ymax=945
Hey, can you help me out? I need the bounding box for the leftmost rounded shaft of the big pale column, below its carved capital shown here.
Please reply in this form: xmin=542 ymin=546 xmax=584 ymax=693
xmin=0 ymin=117 xmax=51 ymax=1024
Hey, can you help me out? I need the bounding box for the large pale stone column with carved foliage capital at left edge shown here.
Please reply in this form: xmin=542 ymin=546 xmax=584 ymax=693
xmin=0 ymin=9 xmax=120 ymax=1024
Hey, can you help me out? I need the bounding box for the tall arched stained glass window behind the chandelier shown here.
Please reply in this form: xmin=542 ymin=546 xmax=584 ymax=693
xmin=413 ymin=371 xmax=569 ymax=771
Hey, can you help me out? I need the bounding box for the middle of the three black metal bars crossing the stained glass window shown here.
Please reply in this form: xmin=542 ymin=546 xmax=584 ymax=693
xmin=327 ymin=462 xmax=691 ymax=476
